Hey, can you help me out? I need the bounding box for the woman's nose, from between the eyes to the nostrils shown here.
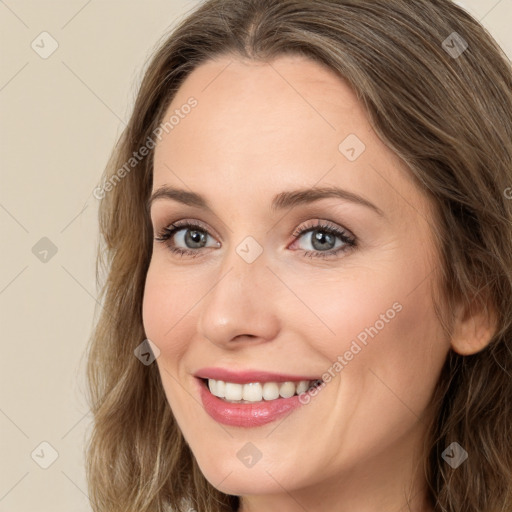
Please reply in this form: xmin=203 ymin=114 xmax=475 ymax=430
xmin=197 ymin=243 xmax=280 ymax=350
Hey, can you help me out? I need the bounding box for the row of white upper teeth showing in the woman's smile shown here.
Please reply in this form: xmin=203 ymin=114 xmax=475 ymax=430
xmin=204 ymin=379 xmax=315 ymax=403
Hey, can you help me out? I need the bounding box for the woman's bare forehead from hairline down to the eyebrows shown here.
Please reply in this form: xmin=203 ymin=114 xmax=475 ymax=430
xmin=153 ymin=56 xmax=428 ymax=223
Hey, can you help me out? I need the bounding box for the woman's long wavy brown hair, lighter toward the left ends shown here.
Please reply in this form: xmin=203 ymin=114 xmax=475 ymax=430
xmin=86 ymin=0 xmax=512 ymax=512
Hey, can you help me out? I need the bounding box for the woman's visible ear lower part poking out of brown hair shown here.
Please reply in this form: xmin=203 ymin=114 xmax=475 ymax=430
xmin=450 ymin=292 xmax=497 ymax=356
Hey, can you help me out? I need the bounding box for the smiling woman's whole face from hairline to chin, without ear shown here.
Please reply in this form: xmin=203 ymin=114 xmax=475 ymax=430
xmin=143 ymin=56 xmax=449 ymax=506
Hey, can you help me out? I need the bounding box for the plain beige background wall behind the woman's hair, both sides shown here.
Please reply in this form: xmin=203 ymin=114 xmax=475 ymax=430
xmin=0 ymin=0 xmax=512 ymax=512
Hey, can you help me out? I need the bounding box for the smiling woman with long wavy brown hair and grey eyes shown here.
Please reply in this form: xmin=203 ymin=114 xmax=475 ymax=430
xmin=88 ymin=0 xmax=512 ymax=512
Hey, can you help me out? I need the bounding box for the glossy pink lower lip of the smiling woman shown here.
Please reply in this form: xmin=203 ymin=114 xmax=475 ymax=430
xmin=198 ymin=379 xmax=302 ymax=428
